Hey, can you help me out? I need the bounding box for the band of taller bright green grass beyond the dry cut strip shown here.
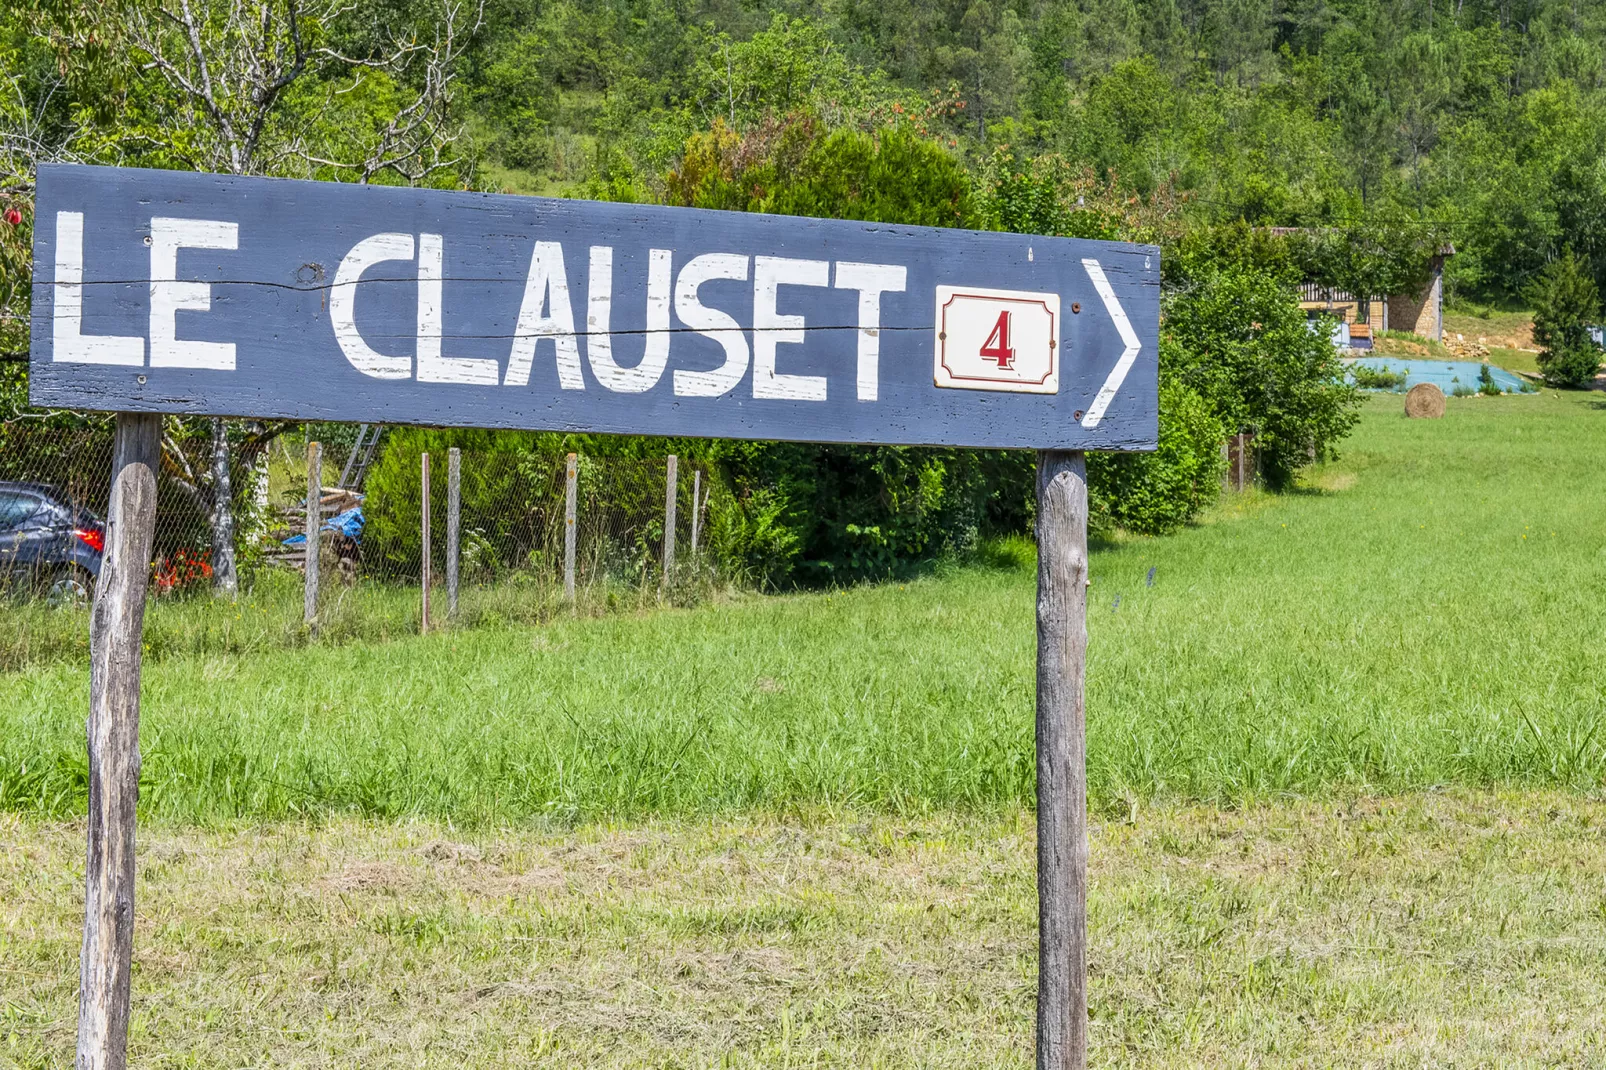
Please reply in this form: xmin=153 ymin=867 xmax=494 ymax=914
xmin=0 ymin=390 xmax=1606 ymax=824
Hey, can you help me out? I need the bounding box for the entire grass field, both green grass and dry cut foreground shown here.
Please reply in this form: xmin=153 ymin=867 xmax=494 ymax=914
xmin=0 ymin=390 xmax=1606 ymax=1070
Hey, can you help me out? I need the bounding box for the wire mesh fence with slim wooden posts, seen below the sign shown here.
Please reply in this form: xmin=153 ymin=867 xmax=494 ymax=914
xmin=0 ymin=424 xmax=719 ymax=631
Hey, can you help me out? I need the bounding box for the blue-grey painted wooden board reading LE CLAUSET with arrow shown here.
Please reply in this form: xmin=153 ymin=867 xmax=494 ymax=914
xmin=31 ymin=165 xmax=1160 ymax=450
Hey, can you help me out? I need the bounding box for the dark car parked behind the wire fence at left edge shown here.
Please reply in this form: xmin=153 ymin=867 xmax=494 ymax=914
xmin=0 ymin=480 xmax=106 ymax=602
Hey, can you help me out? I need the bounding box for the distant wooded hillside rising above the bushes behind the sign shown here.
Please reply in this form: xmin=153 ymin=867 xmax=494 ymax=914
xmin=471 ymin=0 xmax=1606 ymax=299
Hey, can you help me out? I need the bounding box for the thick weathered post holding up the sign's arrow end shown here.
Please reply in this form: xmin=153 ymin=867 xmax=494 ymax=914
xmin=1037 ymin=450 xmax=1087 ymax=1070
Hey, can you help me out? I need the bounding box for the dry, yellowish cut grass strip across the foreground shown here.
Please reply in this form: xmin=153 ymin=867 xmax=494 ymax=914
xmin=0 ymin=794 xmax=1606 ymax=1070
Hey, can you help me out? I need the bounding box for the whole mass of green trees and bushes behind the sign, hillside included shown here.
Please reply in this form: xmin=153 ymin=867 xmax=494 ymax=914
xmin=0 ymin=0 xmax=1606 ymax=583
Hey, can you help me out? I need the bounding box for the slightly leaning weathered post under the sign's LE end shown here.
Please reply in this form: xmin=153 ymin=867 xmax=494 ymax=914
xmin=77 ymin=413 xmax=162 ymax=1070
